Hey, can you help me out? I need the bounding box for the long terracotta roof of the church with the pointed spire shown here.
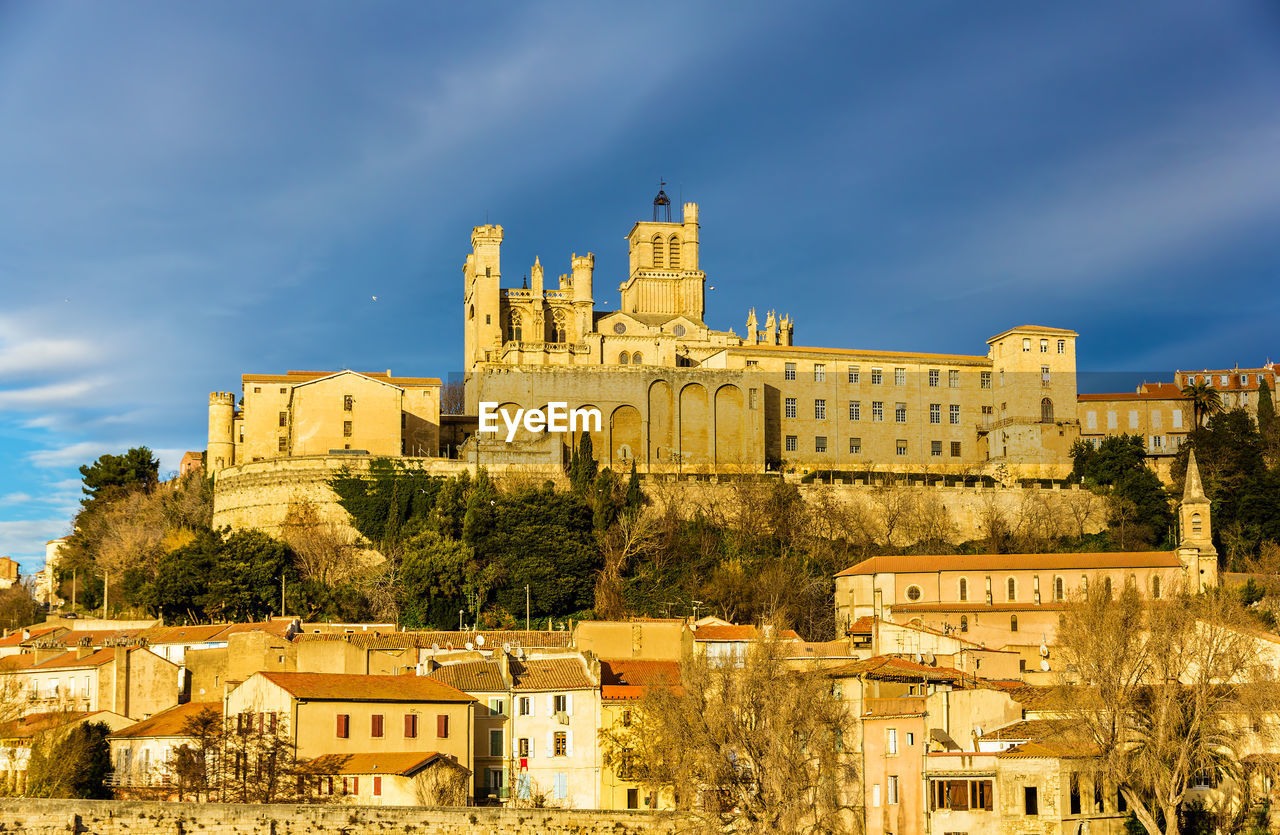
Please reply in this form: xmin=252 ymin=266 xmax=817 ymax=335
xmin=836 ymin=551 xmax=1181 ymax=576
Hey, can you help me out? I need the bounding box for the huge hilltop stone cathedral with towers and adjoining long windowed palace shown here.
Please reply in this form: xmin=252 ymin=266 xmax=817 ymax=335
xmin=463 ymin=193 xmax=1079 ymax=478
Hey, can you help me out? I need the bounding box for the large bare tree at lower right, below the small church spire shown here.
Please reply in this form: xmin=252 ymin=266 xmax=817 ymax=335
xmin=1059 ymin=583 xmax=1276 ymax=835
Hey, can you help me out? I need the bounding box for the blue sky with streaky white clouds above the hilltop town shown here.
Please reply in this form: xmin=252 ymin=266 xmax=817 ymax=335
xmin=0 ymin=0 xmax=1280 ymax=571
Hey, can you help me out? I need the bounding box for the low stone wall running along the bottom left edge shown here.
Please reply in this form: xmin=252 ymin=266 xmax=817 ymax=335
xmin=0 ymin=799 xmax=673 ymax=835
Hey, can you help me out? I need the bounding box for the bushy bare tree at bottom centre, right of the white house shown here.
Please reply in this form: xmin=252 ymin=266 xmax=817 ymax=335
xmin=600 ymin=638 xmax=858 ymax=832
